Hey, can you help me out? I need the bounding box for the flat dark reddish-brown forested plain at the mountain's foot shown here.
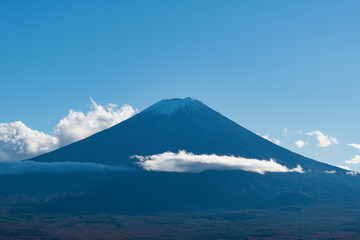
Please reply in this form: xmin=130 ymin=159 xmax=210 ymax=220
xmin=0 ymin=206 xmax=360 ymax=239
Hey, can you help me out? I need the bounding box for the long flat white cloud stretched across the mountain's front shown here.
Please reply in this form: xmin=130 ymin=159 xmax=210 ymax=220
xmin=133 ymin=151 xmax=303 ymax=174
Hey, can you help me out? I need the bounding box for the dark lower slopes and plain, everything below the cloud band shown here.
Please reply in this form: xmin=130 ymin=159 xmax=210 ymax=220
xmin=0 ymin=171 xmax=360 ymax=239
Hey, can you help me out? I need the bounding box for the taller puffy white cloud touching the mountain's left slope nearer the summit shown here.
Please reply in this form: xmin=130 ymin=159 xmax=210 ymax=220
xmin=54 ymin=98 xmax=136 ymax=145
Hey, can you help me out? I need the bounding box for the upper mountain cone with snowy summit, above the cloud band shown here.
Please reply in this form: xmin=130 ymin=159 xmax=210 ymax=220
xmin=31 ymin=98 xmax=336 ymax=172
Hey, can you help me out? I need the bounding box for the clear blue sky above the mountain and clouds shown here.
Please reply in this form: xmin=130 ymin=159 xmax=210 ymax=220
xmin=0 ymin=0 xmax=360 ymax=170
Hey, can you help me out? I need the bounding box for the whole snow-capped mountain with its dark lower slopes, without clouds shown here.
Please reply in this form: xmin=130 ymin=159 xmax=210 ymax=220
xmin=0 ymin=98 xmax=360 ymax=217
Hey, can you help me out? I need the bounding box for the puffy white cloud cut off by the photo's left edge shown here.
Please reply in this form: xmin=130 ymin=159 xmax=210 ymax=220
xmin=0 ymin=121 xmax=59 ymax=160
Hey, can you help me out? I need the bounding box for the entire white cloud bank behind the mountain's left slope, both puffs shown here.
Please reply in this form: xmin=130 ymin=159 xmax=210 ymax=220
xmin=0 ymin=99 xmax=137 ymax=161
